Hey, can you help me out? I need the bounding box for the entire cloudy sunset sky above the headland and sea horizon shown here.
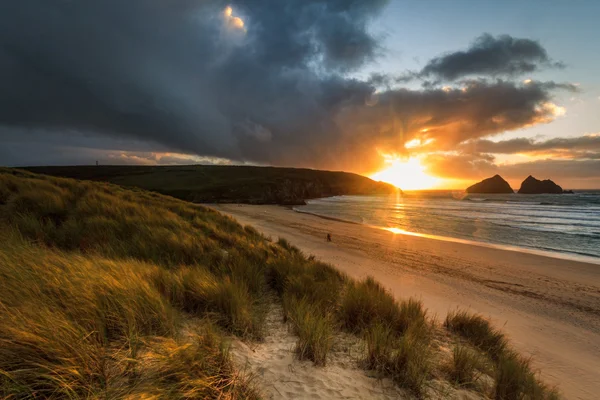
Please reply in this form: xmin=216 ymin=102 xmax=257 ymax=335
xmin=0 ymin=0 xmax=600 ymax=189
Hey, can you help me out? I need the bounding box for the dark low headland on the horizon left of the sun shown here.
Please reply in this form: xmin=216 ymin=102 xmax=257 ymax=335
xmin=22 ymin=165 xmax=398 ymax=205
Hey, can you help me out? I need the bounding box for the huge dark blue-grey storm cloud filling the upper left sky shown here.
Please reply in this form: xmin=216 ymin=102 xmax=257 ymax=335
xmin=0 ymin=0 xmax=385 ymax=166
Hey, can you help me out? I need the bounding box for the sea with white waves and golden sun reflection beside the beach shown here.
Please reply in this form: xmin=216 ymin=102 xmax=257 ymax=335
xmin=295 ymin=190 xmax=600 ymax=264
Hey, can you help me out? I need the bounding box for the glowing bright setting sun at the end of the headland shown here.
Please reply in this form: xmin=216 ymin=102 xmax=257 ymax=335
xmin=371 ymin=157 xmax=441 ymax=190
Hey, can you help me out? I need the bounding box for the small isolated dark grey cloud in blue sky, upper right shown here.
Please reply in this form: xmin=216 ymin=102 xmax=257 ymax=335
xmin=417 ymin=34 xmax=563 ymax=81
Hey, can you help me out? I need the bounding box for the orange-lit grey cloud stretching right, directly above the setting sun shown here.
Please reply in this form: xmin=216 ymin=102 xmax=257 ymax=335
xmin=338 ymin=80 xmax=570 ymax=153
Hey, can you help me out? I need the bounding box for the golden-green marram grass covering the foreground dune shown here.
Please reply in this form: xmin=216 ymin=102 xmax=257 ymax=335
xmin=0 ymin=169 xmax=555 ymax=399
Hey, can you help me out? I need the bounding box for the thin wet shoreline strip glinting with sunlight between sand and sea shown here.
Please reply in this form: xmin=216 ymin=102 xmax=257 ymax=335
xmin=288 ymin=207 xmax=600 ymax=266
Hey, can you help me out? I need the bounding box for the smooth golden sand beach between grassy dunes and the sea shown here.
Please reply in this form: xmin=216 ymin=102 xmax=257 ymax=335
xmin=215 ymin=205 xmax=600 ymax=399
